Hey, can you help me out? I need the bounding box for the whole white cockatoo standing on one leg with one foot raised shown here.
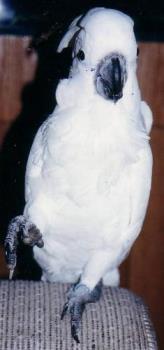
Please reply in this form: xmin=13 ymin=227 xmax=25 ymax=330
xmin=5 ymin=8 xmax=152 ymax=341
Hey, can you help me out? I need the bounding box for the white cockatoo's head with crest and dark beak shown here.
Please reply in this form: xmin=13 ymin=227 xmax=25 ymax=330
xmin=58 ymin=8 xmax=137 ymax=102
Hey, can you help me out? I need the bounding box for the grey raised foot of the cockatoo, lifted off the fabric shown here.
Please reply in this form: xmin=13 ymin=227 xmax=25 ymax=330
xmin=4 ymin=215 xmax=44 ymax=279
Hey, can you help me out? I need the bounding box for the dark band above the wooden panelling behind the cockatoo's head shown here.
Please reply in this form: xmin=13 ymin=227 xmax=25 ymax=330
xmin=1 ymin=0 xmax=164 ymax=40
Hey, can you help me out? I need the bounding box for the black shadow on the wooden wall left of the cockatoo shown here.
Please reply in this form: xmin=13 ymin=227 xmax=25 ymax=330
xmin=0 ymin=35 xmax=71 ymax=279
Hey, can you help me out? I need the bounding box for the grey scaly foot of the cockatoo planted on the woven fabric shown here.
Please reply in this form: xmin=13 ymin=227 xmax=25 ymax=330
xmin=61 ymin=281 xmax=102 ymax=343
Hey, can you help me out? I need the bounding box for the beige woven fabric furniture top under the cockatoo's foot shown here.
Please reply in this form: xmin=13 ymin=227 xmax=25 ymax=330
xmin=0 ymin=281 xmax=157 ymax=350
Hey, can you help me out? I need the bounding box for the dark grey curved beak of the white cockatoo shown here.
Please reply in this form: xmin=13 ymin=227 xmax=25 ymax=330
xmin=95 ymin=53 xmax=127 ymax=103
